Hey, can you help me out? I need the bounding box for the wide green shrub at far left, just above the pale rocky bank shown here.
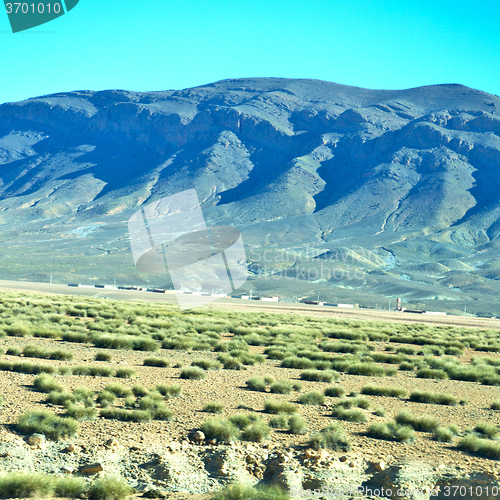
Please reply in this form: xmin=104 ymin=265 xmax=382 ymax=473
xmin=16 ymin=410 xmax=79 ymax=440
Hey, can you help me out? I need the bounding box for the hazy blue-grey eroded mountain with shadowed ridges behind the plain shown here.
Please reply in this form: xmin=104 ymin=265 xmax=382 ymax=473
xmin=0 ymin=78 xmax=500 ymax=312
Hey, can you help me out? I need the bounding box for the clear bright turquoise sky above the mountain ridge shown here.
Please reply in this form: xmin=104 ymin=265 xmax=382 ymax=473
xmin=0 ymin=0 xmax=500 ymax=103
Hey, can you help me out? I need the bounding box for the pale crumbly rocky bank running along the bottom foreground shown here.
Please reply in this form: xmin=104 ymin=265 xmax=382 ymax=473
xmin=0 ymin=438 xmax=500 ymax=500
